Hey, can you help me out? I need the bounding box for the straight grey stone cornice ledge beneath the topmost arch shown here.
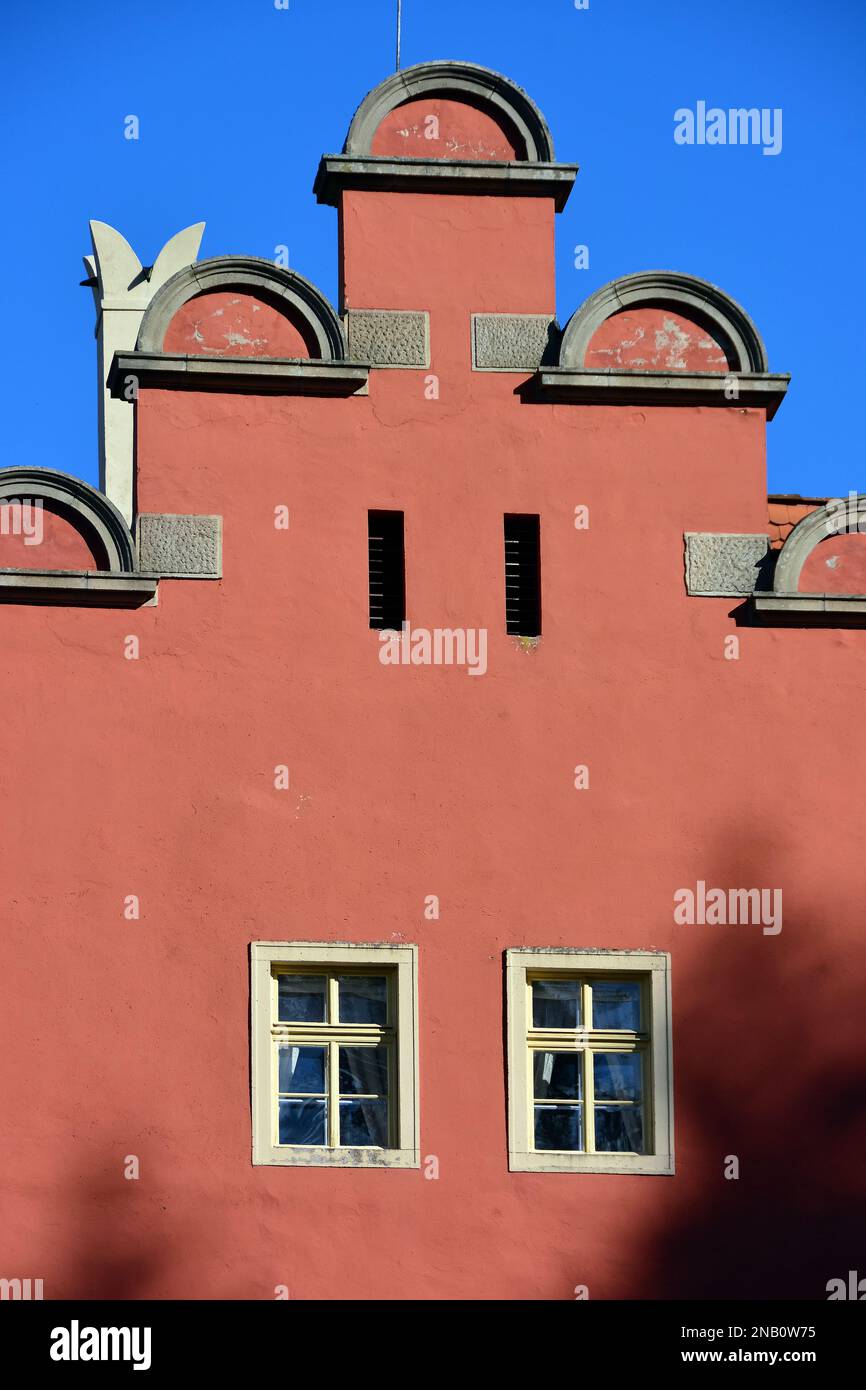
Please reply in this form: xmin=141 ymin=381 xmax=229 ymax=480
xmin=313 ymin=154 xmax=578 ymax=213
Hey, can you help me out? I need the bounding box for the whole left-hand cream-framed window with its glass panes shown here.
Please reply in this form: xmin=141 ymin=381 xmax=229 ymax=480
xmin=250 ymin=941 xmax=420 ymax=1168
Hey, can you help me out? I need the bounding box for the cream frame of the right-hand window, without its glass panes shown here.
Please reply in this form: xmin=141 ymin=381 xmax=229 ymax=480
xmin=506 ymin=947 xmax=674 ymax=1176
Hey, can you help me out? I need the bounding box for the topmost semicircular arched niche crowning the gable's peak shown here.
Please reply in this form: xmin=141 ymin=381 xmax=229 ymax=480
xmin=343 ymin=61 xmax=555 ymax=163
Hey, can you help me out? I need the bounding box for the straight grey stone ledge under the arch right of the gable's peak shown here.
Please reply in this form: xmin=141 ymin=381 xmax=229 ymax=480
xmin=524 ymin=367 xmax=791 ymax=420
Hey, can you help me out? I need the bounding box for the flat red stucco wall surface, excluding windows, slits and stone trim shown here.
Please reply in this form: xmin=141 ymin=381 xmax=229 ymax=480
xmin=0 ymin=84 xmax=866 ymax=1300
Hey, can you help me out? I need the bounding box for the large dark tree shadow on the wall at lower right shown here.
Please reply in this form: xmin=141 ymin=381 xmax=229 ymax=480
xmin=631 ymin=841 xmax=866 ymax=1300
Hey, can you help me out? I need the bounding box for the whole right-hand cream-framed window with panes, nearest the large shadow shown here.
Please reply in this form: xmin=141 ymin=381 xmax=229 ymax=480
xmin=506 ymin=947 xmax=674 ymax=1173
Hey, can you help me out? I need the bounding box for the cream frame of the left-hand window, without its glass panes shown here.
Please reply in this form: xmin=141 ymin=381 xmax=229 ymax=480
xmin=250 ymin=941 xmax=421 ymax=1168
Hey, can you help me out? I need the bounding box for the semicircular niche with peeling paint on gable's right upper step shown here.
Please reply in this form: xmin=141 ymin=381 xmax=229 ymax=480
xmin=559 ymin=271 xmax=767 ymax=375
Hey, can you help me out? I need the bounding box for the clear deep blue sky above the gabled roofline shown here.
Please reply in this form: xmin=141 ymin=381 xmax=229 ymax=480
xmin=0 ymin=0 xmax=866 ymax=495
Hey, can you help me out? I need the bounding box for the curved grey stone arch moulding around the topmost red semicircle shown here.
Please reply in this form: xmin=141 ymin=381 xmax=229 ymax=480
xmin=343 ymin=58 xmax=555 ymax=164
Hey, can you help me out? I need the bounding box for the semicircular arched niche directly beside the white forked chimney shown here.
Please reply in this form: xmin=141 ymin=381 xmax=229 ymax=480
xmin=136 ymin=256 xmax=346 ymax=361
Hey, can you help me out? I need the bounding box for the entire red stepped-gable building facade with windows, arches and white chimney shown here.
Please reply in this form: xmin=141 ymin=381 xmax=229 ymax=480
xmin=0 ymin=63 xmax=866 ymax=1300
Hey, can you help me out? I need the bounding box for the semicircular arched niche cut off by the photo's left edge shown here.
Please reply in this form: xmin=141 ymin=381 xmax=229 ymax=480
xmin=0 ymin=467 xmax=138 ymax=574
